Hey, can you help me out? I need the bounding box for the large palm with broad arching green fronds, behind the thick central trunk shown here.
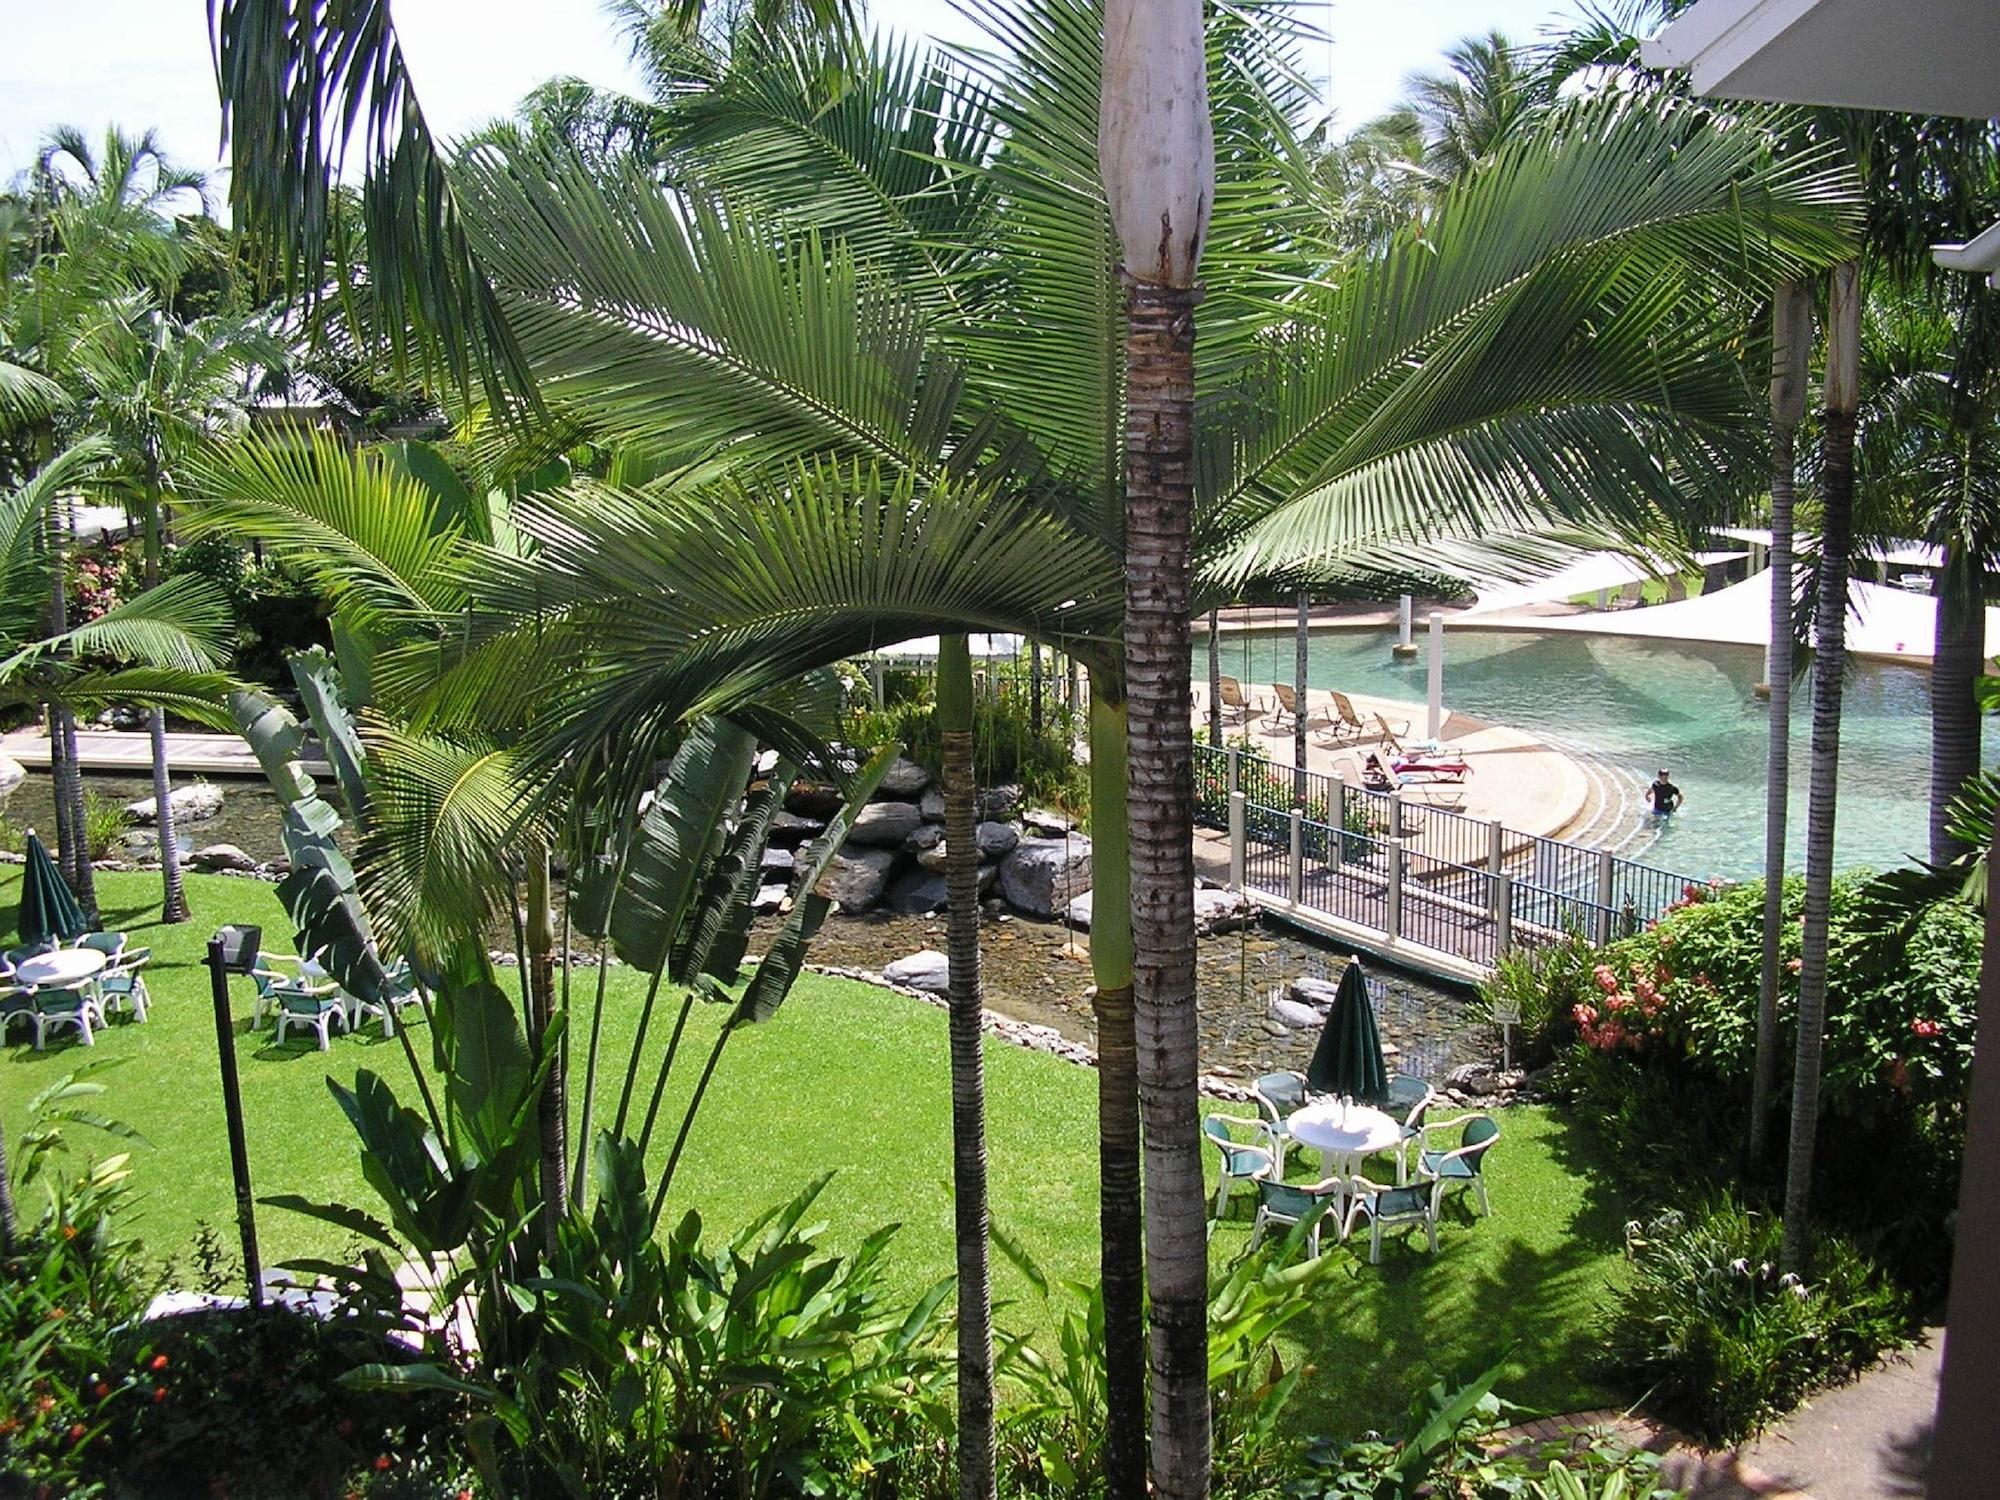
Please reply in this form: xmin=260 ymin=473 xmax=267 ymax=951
xmin=207 ymin=0 xmax=1844 ymax=1492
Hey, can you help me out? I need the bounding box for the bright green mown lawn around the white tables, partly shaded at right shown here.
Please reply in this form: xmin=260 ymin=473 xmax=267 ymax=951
xmin=0 ymin=866 xmax=1628 ymax=1436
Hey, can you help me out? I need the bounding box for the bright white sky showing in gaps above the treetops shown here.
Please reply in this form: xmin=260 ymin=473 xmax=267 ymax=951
xmin=0 ymin=0 xmax=1574 ymax=180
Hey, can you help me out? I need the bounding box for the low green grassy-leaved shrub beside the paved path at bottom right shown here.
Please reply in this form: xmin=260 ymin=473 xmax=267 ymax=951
xmin=1606 ymin=1196 xmax=1910 ymax=1444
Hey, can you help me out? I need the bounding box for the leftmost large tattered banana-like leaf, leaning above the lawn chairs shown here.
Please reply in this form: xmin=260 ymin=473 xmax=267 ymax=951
xmin=230 ymin=690 xmax=392 ymax=1000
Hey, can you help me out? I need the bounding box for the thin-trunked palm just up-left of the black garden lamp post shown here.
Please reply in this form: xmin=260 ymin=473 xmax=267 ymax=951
xmin=76 ymin=308 xmax=284 ymax=922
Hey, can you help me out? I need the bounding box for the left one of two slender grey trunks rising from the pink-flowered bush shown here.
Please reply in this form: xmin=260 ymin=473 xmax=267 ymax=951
xmin=1748 ymin=282 xmax=1812 ymax=1172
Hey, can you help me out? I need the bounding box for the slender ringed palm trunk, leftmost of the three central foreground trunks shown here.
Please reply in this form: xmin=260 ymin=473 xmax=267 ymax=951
xmin=938 ymin=636 xmax=996 ymax=1500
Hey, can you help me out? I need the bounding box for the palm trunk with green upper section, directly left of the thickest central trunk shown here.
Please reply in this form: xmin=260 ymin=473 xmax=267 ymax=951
xmin=1090 ymin=684 xmax=1146 ymax=1500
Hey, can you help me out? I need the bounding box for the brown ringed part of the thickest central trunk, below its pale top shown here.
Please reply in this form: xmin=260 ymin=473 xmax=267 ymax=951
xmin=1126 ymin=280 xmax=1210 ymax=1500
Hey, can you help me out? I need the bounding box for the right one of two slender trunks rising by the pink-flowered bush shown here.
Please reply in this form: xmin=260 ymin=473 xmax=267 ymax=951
xmin=1778 ymin=260 xmax=1862 ymax=1274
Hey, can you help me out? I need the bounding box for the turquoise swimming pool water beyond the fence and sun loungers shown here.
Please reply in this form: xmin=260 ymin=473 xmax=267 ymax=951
xmin=1194 ymin=630 xmax=2000 ymax=878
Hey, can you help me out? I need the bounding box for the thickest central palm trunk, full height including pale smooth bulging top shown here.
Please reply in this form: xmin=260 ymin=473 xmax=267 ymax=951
xmin=1092 ymin=0 xmax=1216 ymax=1500
